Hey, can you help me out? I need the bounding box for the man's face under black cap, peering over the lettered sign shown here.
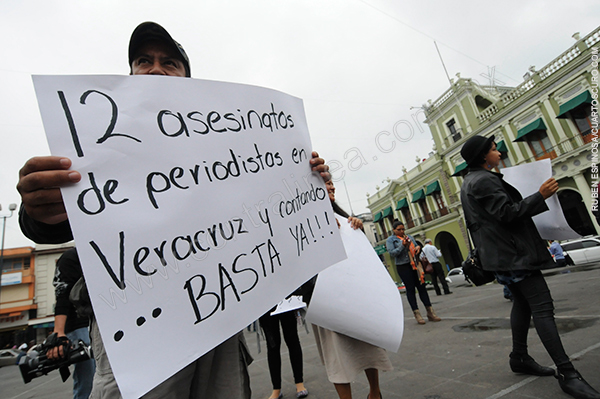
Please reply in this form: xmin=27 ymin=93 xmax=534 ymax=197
xmin=131 ymin=42 xmax=185 ymax=77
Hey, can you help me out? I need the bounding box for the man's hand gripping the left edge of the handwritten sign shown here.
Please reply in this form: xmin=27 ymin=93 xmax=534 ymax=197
xmin=17 ymin=156 xmax=81 ymax=224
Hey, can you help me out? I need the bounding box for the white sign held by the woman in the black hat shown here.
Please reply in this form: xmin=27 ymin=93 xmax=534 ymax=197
xmin=502 ymin=159 xmax=580 ymax=240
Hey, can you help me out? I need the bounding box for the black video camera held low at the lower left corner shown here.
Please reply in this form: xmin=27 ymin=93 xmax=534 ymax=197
xmin=19 ymin=333 xmax=93 ymax=384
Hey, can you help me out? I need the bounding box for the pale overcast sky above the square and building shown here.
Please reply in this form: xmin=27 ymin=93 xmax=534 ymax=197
xmin=0 ymin=0 xmax=600 ymax=248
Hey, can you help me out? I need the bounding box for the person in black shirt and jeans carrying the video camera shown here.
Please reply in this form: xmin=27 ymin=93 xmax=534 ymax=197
xmin=47 ymin=248 xmax=96 ymax=399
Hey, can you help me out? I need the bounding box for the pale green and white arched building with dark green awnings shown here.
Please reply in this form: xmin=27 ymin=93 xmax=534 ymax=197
xmin=368 ymin=28 xmax=600 ymax=278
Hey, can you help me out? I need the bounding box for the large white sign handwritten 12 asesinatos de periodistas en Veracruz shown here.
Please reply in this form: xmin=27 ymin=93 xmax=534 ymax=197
xmin=34 ymin=76 xmax=345 ymax=399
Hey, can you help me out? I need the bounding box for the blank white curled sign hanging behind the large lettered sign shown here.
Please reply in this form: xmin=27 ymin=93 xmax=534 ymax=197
xmin=306 ymin=216 xmax=404 ymax=352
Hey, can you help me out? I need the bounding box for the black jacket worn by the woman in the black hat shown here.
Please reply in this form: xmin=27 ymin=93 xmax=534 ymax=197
xmin=460 ymin=168 xmax=556 ymax=271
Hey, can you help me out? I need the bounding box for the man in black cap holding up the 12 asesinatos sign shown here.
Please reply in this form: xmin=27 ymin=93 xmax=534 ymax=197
xmin=17 ymin=22 xmax=329 ymax=399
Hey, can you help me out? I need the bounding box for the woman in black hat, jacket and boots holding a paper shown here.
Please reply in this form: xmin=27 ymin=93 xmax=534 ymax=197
xmin=460 ymin=136 xmax=600 ymax=399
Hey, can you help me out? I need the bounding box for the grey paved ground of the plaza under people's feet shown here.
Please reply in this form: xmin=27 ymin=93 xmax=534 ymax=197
xmin=246 ymin=264 xmax=600 ymax=399
